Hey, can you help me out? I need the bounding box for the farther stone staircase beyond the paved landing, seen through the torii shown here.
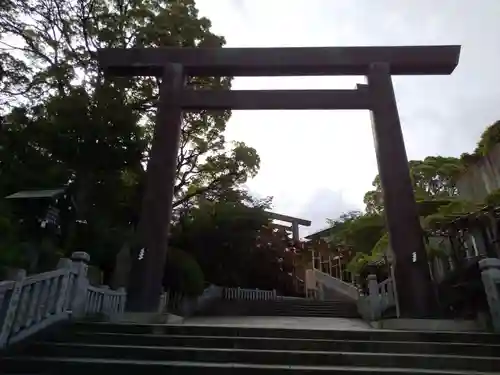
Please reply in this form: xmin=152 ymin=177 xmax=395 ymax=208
xmin=198 ymin=299 xmax=359 ymax=318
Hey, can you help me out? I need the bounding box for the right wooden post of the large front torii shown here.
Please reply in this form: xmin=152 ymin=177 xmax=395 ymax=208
xmin=367 ymin=62 xmax=436 ymax=317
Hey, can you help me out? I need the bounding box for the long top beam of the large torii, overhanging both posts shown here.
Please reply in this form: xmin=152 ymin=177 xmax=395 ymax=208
xmin=97 ymin=45 xmax=460 ymax=77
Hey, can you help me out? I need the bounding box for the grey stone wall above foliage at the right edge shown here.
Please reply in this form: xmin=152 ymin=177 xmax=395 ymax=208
xmin=457 ymin=144 xmax=500 ymax=202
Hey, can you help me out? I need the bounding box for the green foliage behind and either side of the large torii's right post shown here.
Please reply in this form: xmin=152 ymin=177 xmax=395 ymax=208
xmin=328 ymin=121 xmax=500 ymax=274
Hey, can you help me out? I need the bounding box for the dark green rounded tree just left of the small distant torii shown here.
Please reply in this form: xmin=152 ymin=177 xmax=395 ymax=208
xmin=170 ymin=194 xmax=268 ymax=286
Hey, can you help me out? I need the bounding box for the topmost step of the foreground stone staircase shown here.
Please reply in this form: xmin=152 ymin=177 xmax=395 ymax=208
xmin=66 ymin=322 xmax=500 ymax=344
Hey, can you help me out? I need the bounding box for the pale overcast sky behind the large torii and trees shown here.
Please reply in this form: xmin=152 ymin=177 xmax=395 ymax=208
xmin=197 ymin=0 xmax=500 ymax=235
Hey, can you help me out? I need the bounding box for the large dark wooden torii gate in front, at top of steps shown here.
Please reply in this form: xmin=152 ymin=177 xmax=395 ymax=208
xmin=98 ymin=46 xmax=460 ymax=317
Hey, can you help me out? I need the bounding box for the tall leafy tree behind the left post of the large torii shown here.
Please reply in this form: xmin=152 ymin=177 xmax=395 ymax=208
xmin=0 ymin=0 xmax=259 ymax=270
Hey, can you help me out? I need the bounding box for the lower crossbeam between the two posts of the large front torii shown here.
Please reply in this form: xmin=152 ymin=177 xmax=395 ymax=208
xmin=181 ymin=90 xmax=370 ymax=111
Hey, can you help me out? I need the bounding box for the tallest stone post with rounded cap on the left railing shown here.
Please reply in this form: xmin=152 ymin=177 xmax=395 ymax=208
xmin=70 ymin=251 xmax=90 ymax=318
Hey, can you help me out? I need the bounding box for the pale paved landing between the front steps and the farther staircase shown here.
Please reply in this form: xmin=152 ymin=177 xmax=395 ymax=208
xmin=184 ymin=316 xmax=372 ymax=330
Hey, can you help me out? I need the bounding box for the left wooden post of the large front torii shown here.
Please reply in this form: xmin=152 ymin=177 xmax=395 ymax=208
xmin=127 ymin=64 xmax=184 ymax=312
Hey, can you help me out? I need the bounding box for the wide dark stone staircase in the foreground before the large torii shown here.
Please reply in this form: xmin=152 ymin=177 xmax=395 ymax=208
xmin=0 ymin=323 xmax=500 ymax=375
